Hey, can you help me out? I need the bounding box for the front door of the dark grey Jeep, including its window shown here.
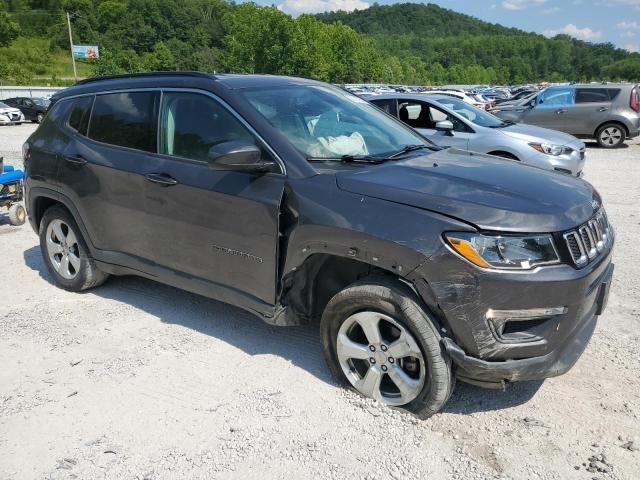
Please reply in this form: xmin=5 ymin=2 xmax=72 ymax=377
xmin=144 ymin=90 xmax=285 ymax=305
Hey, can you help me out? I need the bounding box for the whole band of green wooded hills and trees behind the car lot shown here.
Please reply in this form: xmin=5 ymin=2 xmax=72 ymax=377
xmin=0 ymin=0 xmax=640 ymax=85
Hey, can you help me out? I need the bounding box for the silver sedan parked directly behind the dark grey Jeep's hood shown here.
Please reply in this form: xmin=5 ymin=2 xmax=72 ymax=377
xmin=363 ymin=94 xmax=585 ymax=176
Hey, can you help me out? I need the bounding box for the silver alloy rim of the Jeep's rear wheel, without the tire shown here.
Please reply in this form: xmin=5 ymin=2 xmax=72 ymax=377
xmin=46 ymin=219 xmax=80 ymax=280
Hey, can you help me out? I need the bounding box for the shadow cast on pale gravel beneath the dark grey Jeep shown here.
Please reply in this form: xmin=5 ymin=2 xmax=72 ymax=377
xmin=23 ymin=246 xmax=542 ymax=415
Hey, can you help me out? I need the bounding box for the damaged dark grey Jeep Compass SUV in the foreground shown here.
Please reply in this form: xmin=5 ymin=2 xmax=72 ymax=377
xmin=23 ymin=72 xmax=614 ymax=417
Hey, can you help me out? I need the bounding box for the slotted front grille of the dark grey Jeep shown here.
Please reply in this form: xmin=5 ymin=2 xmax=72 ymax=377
xmin=563 ymin=209 xmax=613 ymax=267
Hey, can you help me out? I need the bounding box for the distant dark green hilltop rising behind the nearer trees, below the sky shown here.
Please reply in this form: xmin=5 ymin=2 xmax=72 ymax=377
xmin=316 ymin=3 xmax=525 ymax=37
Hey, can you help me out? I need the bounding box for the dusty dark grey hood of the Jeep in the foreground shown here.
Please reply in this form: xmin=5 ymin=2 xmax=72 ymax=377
xmin=336 ymin=149 xmax=601 ymax=233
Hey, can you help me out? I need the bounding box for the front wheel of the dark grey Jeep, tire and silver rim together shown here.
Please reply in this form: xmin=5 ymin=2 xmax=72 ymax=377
xmin=320 ymin=277 xmax=455 ymax=419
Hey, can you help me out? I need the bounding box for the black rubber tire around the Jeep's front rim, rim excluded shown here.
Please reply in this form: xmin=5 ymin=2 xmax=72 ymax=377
xmin=320 ymin=282 xmax=454 ymax=418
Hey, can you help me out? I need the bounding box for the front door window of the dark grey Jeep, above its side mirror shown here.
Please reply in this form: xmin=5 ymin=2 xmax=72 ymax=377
xmin=159 ymin=92 xmax=266 ymax=166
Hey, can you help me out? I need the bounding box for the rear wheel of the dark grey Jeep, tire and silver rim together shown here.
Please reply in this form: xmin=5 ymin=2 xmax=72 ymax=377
xmin=39 ymin=205 xmax=109 ymax=292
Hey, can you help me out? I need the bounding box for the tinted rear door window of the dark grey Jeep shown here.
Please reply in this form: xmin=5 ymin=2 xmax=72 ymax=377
xmin=89 ymin=92 xmax=159 ymax=152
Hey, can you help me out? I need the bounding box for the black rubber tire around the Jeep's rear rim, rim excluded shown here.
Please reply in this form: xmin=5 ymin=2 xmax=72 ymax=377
xmin=38 ymin=207 xmax=89 ymax=292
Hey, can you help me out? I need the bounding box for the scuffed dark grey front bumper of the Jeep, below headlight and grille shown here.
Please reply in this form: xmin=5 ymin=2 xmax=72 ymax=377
xmin=414 ymin=238 xmax=614 ymax=383
